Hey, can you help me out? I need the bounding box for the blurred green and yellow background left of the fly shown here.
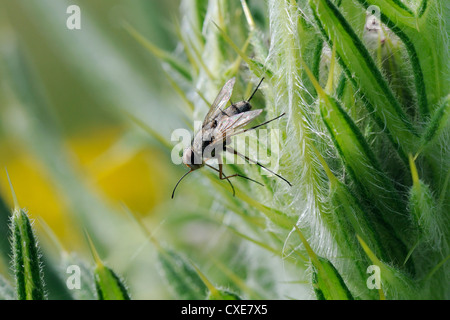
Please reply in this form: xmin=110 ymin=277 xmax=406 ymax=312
xmin=0 ymin=0 xmax=207 ymax=298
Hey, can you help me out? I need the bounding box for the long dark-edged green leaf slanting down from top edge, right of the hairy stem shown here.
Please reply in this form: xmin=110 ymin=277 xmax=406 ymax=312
xmin=309 ymin=0 xmax=417 ymax=163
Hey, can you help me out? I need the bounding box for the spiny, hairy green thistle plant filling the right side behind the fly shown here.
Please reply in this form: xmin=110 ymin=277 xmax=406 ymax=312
xmin=131 ymin=0 xmax=450 ymax=299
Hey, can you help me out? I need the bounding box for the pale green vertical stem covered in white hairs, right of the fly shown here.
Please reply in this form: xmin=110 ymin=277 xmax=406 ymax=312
xmin=267 ymin=0 xmax=344 ymax=241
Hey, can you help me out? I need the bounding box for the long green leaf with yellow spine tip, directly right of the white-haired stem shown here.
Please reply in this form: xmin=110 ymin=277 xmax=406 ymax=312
xmin=304 ymin=58 xmax=407 ymax=265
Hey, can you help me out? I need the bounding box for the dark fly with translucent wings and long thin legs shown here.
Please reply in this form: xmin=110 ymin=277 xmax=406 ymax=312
xmin=172 ymin=78 xmax=292 ymax=199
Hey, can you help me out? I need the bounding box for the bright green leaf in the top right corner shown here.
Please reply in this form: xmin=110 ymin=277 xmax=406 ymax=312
xmin=358 ymin=0 xmax=450 ymax=115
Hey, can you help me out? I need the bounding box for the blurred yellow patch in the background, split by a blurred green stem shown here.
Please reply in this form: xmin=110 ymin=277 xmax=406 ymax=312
xmin=0 ymin=127 xmax=171 ymax=250
